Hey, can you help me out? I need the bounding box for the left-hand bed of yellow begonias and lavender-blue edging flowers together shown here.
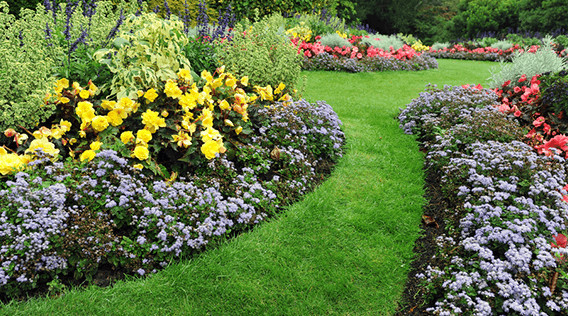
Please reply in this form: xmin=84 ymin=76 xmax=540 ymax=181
xmin=0 ymin=71 xmax=344 ymax=299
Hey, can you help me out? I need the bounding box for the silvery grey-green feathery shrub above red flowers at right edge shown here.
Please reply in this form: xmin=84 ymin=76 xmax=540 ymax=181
xmin=489 ymin=37 xmax=567 ymax=87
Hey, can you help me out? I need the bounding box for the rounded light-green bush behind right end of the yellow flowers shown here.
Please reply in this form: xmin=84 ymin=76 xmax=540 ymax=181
xmin=218 ymin=15 xmax=302 ymax=91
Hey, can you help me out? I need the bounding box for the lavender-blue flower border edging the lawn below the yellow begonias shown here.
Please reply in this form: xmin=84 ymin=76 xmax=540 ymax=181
xmin=0 ymin=100 xmax=344 ymax=298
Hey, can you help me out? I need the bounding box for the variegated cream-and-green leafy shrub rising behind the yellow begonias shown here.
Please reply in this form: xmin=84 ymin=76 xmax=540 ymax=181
xmin=95 ymin=13 xmax=190 ymax=98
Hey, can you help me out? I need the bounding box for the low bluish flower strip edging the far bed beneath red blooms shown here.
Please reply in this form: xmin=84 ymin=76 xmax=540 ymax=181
xmin=302 ymin=52 xmax=438 ymax=72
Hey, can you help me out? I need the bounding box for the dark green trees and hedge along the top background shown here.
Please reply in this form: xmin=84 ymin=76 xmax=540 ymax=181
xmin=6 ymin=0 xmax=568 ymax=44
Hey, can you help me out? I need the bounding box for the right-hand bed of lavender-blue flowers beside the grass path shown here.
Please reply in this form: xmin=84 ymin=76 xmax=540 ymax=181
xmin=399 ymin=82 xmax=568 ymax=315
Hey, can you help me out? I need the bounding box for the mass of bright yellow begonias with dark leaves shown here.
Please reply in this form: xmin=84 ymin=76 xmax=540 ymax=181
xmin=0 ymin=67 xmax=291 ymax=175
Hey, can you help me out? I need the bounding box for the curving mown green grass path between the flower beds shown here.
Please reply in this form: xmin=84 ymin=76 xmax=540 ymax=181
xmin=0 ymin=60 xmax=494 ymax=315
